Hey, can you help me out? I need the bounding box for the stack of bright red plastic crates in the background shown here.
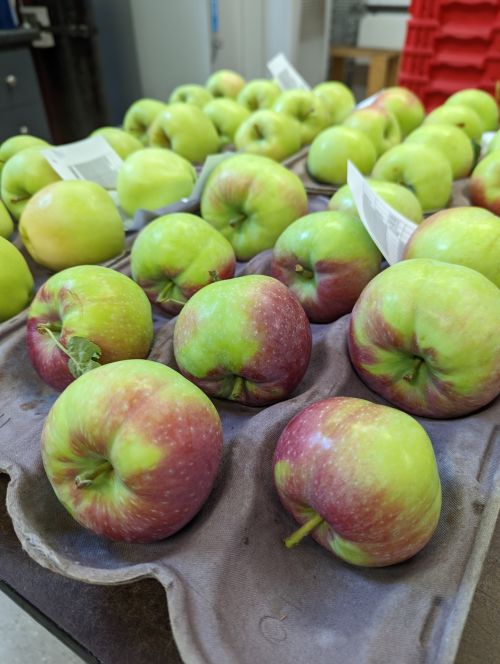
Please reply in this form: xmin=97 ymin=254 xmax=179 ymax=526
xmin=399 ymin=0 xmax=500 ymax=111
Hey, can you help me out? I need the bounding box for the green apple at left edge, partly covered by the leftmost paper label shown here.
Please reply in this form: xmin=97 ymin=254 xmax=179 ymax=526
xmin=1 ymin=147 xmax=61 ymax=220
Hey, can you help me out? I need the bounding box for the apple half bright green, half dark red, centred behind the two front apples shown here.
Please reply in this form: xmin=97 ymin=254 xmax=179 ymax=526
xmin=174 ymin=275 xmax=311 ymax=406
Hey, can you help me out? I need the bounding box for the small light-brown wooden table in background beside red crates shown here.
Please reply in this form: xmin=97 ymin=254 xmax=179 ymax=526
xmin=330 ymin=46 xmax=400 ymax=97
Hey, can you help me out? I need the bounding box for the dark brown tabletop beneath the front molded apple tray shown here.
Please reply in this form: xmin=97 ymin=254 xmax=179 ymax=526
xmin=0 ymin=466 xmax=500 ymax=664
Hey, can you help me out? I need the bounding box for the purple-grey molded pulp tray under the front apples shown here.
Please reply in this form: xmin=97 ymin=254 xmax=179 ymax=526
xmin=0 ymin=188 xmax=500 ymax=664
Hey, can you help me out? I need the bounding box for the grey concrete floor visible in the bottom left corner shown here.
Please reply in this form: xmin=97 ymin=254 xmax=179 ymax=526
xmin=0 ymin=592 xmax=82 ymax=664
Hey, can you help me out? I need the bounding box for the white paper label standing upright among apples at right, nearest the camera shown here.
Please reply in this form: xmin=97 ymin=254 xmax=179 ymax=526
xmin=347 ymin=161 xmax=417 ymax=265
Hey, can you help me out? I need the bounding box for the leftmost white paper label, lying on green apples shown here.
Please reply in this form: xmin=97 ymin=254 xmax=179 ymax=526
xmin=42 ymin=136 xmax=123 ymax=190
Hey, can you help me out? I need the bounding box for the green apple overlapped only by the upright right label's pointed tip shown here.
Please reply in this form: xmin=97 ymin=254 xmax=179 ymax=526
xmin=307 ymin=126 xmax=377 ymax=185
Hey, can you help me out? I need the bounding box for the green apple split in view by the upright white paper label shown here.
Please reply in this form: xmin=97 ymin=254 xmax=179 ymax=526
xmin=328 ymin=178 xmax=424 ymax=224
